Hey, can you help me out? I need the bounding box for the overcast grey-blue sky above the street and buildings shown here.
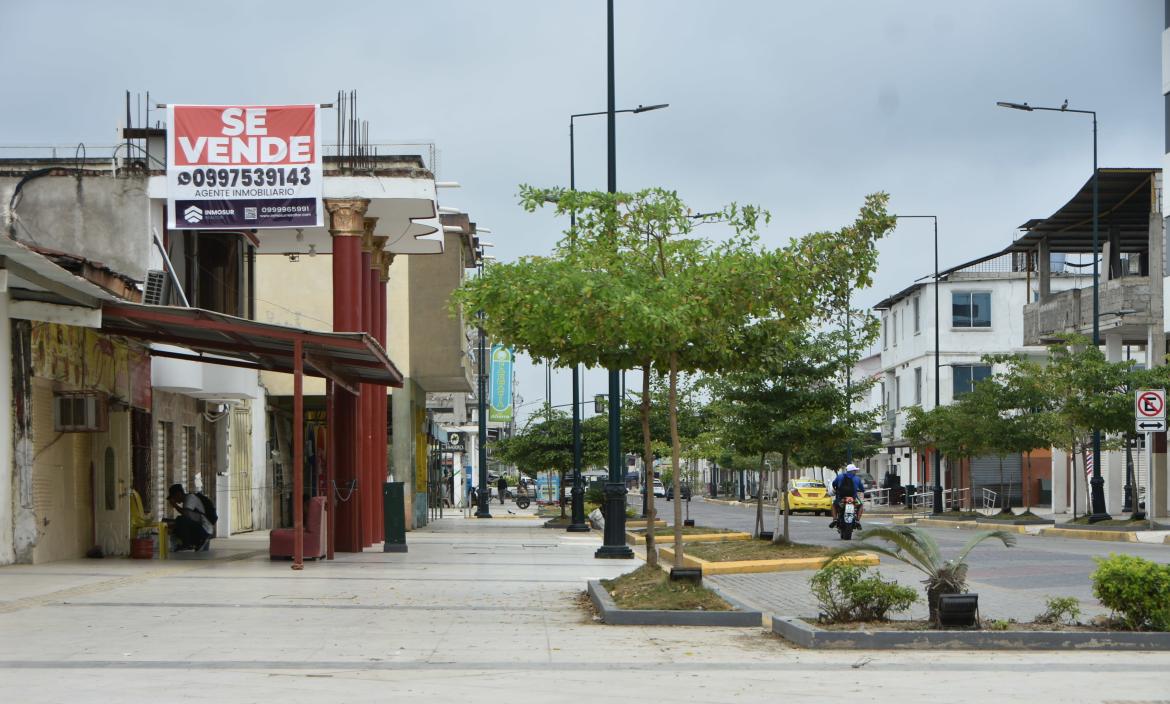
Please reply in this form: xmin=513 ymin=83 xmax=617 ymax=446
xmin=0 ymin=0 xmax=1163 ymax=415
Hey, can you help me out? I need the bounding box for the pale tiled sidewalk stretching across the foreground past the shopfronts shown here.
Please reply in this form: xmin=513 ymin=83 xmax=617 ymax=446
xmin=0 ymin=516 xmax=1170 ymax=704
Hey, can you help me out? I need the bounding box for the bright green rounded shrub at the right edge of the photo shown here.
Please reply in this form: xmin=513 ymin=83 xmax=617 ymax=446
xmin=1092 ymin=554 xmax=1170 ymax=630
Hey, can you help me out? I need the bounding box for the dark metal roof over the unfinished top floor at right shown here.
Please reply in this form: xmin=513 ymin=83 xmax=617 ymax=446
xmin=1005 ymin=168 xmax=1162 ymax=254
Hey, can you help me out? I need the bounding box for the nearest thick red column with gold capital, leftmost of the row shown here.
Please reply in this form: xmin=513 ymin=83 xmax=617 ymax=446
xmin=327 ymin=194 xmax=370 ymax=552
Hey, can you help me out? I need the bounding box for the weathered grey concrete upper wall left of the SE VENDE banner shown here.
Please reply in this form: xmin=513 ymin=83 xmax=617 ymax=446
xmin=0 ymin=170 xmax=153 ymax=281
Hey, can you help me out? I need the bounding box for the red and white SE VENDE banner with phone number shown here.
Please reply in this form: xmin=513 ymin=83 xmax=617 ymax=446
xmin=166 ymin=105 xmax=324 ymax=229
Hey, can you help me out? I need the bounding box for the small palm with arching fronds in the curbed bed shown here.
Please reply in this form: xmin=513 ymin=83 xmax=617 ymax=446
xmin=826 ymin=525 xmax=1016 ymax=624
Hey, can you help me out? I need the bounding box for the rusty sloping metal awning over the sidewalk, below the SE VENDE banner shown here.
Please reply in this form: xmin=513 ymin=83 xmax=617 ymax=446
xmin=102 ymin=302 xmax=402 ymax=391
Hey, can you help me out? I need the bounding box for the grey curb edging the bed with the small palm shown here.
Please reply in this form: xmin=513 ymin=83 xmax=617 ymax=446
xmin=772 ymin=616 xmax=1170 ymax=650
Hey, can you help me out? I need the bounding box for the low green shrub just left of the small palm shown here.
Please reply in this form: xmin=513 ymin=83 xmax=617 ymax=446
xmin=808 ymin=562 xmax=918 ymax=623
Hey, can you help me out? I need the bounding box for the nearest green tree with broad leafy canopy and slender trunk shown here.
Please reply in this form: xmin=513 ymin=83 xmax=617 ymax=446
xmin=453 ymin=187 xmax=894 ymax=560
